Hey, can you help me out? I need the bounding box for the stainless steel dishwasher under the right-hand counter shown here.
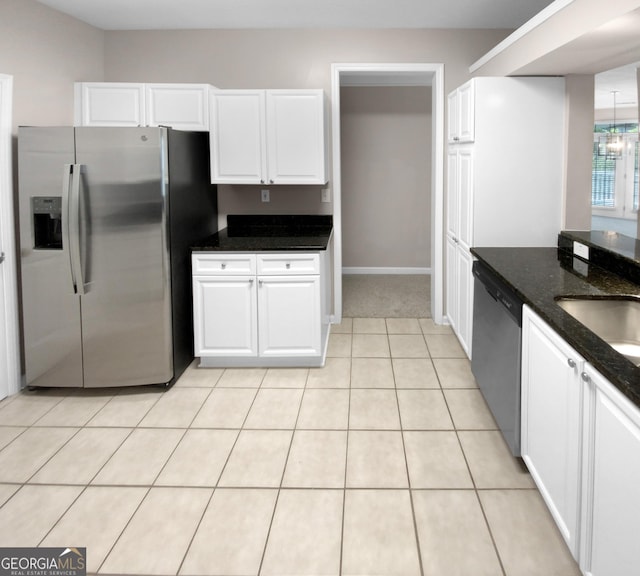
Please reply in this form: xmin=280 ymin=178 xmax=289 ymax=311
xmin=471 ymin=261 xmax=522 ymax=456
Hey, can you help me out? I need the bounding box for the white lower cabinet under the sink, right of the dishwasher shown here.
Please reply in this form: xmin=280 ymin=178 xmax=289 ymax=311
xmin=522 ymin=306 xmax=640 ymax=576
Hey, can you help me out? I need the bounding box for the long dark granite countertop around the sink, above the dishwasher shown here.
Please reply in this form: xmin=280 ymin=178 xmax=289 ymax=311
xmin=471 ymin=243 xmax=640 ymax=407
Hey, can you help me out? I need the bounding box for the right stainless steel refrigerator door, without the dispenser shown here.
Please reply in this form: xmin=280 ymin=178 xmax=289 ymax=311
xmin=76 ymin=128 xmax=173 ymax=387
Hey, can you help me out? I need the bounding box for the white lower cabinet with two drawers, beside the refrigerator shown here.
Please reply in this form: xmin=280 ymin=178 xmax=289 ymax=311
xmin=192 ymin=252 xmax=329 ymax=366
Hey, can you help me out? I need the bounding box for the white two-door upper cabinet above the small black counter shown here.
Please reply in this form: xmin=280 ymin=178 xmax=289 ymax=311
xmin=211 ymin=90 xmax=328 ymax=184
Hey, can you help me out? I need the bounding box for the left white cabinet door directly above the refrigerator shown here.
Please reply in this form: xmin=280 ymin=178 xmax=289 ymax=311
xmin=75 ymin=82 xmax=145 ymax=126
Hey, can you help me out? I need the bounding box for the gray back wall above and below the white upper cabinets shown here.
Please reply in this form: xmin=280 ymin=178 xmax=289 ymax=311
xmin=105 ymin=30 xmax=508 ymax=227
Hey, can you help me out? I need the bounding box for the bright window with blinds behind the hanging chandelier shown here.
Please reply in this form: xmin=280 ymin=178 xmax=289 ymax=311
xmin=591 ymin=122 xmax=639 ymax=219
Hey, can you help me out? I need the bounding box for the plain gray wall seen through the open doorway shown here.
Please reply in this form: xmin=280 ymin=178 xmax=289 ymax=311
xmin=340 ymin=86 xmax=431 ymax=268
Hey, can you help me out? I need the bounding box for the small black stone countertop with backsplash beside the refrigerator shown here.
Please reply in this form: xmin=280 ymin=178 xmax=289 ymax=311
xmin=191 ymin=215 xmax=333 ymax=252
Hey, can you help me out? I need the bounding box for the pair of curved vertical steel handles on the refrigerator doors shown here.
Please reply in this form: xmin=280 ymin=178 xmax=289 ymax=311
xmin=62 ymin=164 xmax=85 ymax=295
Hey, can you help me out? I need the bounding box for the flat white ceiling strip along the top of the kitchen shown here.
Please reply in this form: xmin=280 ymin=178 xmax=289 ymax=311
xmin=39 ymin=0 xmax=551 ymax=30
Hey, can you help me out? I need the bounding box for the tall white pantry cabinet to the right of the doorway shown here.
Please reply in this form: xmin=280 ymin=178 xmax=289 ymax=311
xmin=445 ymin=77 xmax=565 ymax=358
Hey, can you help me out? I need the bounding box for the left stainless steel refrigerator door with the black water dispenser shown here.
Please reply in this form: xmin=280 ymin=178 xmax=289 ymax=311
xmin=18 ymin=127 xmax=83 ymax=387
